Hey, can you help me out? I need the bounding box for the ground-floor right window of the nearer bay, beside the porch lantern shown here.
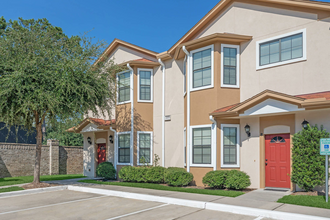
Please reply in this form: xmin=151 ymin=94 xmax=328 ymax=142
xmin=221 ymin=124 xmax=240 ymax=167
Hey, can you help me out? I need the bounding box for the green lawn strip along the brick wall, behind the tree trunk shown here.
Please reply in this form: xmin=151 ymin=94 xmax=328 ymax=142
xmin=0 ymin=174 xmax=84 ymax=186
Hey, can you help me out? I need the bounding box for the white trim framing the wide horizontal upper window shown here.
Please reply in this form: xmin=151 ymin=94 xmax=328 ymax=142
xmin=256 ymin=28 xmax=307 ymax=70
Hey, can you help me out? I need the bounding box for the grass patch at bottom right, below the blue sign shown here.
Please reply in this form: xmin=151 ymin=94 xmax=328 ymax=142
xmin=277 ymin=195 xmax=330 ymax=209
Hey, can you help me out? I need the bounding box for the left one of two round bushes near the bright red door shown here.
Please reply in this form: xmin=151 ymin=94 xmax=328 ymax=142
xmin=203 ymin=170 xmax=229 ymax=189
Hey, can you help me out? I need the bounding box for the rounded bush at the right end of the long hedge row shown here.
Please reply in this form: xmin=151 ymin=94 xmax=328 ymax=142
xmin=165 ymin=167 xmax=194 ymax=186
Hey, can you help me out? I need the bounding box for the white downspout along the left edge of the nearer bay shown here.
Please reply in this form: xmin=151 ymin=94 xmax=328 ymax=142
xmin=182 ymin=46 xmax=191 ymax=172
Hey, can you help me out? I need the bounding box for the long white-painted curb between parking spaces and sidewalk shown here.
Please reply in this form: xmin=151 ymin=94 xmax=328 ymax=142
xmin=67 ymin=185 xmax=329 ymax=220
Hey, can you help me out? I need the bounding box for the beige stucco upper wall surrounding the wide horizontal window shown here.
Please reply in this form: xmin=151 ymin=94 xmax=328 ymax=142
xmin=196 ymin=3 xmax=330 ymax=101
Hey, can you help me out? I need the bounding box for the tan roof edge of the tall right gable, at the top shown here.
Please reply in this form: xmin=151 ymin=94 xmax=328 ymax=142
xmin=167 ymin=0 xmax=330 ymax=54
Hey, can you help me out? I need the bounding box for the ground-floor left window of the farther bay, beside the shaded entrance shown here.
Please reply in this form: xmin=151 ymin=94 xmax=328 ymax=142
xmin=117 ymin=131 xmax=132 ymax=165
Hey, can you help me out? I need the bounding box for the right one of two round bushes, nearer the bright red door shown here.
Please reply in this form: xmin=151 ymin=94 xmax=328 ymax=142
xmin=225 ymin=170 xmax=251 ymax=189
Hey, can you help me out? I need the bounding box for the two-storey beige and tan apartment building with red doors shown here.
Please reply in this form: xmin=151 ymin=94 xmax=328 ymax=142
xmin=70 ymin=0 xmax=330 ymax=189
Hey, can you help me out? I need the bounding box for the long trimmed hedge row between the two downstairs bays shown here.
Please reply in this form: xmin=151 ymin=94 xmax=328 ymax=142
xmin=118 ymin=166 xmax=193 ymax=186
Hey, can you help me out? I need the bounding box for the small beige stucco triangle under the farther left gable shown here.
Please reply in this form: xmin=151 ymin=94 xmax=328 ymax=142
xmin=109 ymin=45 xmax=157 ymax=63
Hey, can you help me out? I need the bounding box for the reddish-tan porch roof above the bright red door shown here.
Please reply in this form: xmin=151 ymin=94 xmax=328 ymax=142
xmin=210 ymin=90 xmax=330 ymax=117
